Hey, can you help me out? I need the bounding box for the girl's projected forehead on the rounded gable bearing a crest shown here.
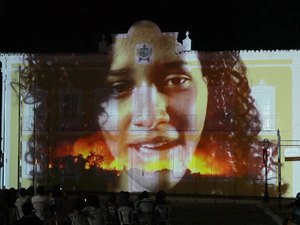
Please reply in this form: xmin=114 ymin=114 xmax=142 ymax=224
xmin=112 ymin=21 xmax=180 ymax=68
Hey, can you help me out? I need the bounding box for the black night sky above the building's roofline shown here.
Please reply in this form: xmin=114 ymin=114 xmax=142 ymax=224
xmin=0 ymin=0 xmax=300 ymax=52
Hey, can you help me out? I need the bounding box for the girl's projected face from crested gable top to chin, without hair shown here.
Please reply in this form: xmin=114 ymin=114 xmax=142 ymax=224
xmin=98 ymin=23 xmax=207 ymax=190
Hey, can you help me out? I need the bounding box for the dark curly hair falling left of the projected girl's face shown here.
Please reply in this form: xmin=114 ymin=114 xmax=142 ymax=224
xmin=15 ymin=54 xmax=108 ymax=177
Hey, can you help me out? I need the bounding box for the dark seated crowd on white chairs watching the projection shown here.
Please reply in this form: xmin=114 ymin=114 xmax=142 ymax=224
xmin=0 ymin=185 xmax=171 ymax=225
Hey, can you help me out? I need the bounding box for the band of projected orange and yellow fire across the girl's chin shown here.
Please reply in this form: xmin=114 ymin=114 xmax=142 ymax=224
xmin=50 ymin=134 xmax=228 ymax=175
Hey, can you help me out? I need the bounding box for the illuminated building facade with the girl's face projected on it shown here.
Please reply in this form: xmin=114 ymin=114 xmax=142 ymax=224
xmin=2 ymin=22 xmax=300 ymax=197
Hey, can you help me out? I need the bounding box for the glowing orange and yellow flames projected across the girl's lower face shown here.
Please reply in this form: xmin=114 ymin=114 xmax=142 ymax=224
xmin=49 ymin=133 xmax=230 ymax=175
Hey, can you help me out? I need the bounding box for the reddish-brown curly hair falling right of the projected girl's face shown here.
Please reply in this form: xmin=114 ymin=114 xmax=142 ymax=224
xmin=199 ymin=51 xmax=262 ymax=177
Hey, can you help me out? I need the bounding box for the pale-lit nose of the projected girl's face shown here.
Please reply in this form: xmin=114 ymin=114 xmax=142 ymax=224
xmin=132 ymin=85 xmax=170 ymax=130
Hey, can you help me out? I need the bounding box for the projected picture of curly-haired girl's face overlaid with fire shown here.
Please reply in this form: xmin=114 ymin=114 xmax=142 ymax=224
xmin=21 ymin=21 xmax=275 ymax=193
